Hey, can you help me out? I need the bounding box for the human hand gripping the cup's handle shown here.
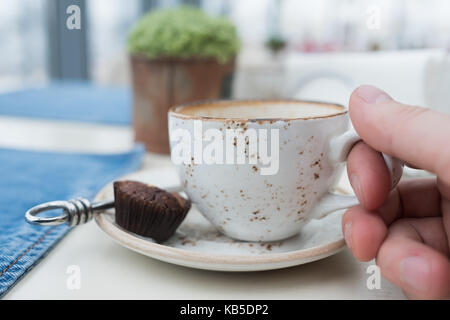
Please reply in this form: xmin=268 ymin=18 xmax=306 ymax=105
xmin=342 ymin=86 xmax=450 ymax=299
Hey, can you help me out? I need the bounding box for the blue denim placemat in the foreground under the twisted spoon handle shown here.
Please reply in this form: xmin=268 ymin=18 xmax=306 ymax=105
xmin=0 ymin=146 xmax=144 ymax=297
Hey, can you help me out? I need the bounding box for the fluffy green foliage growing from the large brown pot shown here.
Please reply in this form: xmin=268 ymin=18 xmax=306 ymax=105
xmin=128 ymin=6 xmax=240 ymax=63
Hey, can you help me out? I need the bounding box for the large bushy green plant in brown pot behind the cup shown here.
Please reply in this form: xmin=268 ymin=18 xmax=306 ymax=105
xmin=128 ymin=7 xmax=240 ymax=153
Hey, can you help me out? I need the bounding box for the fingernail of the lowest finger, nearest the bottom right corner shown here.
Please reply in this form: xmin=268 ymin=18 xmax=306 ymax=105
xmin=400 ymin=256 xmax=430 ymax=292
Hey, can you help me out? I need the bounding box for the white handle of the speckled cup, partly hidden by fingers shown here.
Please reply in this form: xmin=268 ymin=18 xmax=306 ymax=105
xmin=310 ymin=128 xmax=404 ymax=219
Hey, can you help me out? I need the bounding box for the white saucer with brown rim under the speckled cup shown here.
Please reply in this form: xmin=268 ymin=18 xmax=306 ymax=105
xmin=95 ymin=168 xmax=345 ymax=271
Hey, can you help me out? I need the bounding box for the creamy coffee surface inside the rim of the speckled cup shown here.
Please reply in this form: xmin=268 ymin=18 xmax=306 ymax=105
xmin=176 ymin=101 xmax=345 ymax=119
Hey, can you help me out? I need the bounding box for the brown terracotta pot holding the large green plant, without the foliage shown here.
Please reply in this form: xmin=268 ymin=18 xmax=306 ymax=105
xmin=131 ymin=55 xmax=234 ymax=153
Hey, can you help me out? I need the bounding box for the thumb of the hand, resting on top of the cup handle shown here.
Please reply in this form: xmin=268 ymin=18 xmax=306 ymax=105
xmin=349 ymin=85 xmax=450 ymax=184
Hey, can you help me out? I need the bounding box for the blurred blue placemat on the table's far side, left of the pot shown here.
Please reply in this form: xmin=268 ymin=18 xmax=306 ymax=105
xmin=0 ymin=82 xmax=132 ymax=125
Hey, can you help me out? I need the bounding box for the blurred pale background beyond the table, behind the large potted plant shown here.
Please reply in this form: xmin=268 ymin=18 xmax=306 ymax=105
xmin=0 ymin=0 xmax=450 ymax=122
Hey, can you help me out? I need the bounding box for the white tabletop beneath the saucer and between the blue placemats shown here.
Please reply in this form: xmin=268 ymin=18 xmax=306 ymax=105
xmin=0 ymin=117 xmax=404 ymax=299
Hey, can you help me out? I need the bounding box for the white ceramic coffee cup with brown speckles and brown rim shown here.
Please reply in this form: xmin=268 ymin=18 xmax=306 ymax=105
xmin=169 ymin=100 xmax=403 ymax=241
